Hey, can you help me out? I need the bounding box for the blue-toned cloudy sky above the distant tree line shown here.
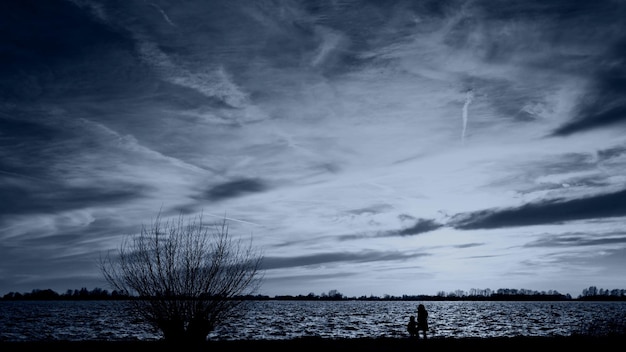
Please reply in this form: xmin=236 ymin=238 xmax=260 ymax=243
xmin=0 ymin=0 xmax=626 ymax=297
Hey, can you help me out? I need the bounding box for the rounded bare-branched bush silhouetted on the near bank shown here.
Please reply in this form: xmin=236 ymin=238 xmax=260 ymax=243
xmin=100 ymin=213 xmax=262 ymax=342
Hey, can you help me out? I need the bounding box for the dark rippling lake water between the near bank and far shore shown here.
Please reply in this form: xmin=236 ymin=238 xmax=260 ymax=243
xmin=0 ymin=301 xmax=626 ymax=341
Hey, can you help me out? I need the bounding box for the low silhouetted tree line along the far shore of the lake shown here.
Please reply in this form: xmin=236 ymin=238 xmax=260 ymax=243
xmin=1 ymin=286 xmax=626 ymax=301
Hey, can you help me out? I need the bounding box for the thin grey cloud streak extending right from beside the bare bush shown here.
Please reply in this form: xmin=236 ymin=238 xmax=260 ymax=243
xmin=263 ymin=251 xmax=427 ymax=269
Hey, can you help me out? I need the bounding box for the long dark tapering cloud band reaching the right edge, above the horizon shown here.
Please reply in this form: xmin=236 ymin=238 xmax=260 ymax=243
xmin=450 ymin=190 xmax=626 ymax=230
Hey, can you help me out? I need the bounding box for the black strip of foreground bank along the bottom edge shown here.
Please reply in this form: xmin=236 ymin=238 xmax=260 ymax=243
xmin=0 ymin=336 xmax=626 ymax=352
